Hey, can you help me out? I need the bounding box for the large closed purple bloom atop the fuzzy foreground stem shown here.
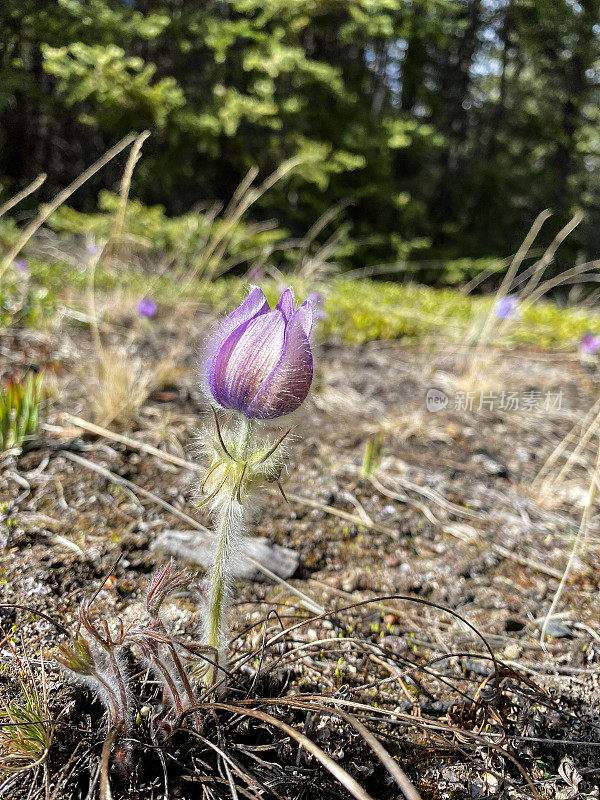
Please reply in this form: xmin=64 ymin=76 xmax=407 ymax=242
xmin=205 ymin=287 xmax=313 ymax=419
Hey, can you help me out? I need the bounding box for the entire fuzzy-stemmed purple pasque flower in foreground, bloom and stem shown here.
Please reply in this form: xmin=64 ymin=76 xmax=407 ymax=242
xmin=199 ymin=287 xmax=313 ymax=687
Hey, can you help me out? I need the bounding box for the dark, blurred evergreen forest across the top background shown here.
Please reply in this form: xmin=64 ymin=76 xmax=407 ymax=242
xmin=0 ymin=0 xmax=600 ymax=281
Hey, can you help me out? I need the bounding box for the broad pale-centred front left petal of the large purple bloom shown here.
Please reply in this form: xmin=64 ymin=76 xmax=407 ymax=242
xmin=208 ymin=310 xmax=285 ymax=412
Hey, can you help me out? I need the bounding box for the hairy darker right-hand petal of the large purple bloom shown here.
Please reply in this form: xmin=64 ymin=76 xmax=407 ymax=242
xmin=246 ymin=309 xmax=313 ymax=419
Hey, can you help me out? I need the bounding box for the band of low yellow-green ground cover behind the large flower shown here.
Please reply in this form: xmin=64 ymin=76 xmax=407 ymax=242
xmin=0 ymin=258 xmax=600 ymax=351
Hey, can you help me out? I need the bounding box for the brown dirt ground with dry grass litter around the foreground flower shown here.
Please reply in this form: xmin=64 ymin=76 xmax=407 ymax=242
xmin=0 ymin=322 xmax=600 ymax=800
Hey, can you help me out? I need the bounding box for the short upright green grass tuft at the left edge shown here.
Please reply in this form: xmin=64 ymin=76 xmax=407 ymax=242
xmin=0 ymin=373 xmax=43 ymax=451
